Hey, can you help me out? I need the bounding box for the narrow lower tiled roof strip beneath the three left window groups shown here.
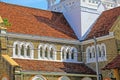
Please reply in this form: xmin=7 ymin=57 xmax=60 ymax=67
xmin=14 ymin=59 xmax=95 ymax=74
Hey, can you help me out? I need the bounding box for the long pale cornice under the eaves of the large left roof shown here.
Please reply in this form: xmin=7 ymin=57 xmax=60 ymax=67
xmin=4 ymin=33 xmax=81 ymax=45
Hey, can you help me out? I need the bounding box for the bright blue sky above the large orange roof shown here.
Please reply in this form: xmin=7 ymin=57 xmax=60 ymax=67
xmin=0 ymin=0 xmax=60 ymax=9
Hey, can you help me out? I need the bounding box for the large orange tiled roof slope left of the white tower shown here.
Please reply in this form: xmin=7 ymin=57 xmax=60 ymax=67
xmin=0 ymin=2 xmax=77 ymax=39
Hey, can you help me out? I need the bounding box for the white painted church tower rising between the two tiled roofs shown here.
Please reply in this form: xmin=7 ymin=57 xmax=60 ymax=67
xmin=47 ymin=0 xmax=120 ymax=40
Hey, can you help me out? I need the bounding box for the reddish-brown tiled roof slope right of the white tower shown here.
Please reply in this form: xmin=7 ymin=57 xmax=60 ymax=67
xmin=86 ymin=7 xmax=120 ymax=39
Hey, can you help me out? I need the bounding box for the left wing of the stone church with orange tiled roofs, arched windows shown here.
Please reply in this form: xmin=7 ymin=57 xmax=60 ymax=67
xmin=0 ymin=2 xmax=96 ymax=80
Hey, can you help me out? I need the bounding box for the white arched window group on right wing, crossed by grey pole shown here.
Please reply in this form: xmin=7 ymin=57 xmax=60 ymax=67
xmin=86 ymin=43 xmax=106 ymax=63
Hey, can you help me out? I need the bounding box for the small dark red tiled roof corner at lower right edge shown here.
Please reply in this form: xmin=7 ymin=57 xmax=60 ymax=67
xmin=103 ymin=55 xmax=120 ymax=70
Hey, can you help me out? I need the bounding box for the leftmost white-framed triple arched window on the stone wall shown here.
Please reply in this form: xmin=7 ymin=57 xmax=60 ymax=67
xmin=13 ymin=41 xmax=34 ymax=58
